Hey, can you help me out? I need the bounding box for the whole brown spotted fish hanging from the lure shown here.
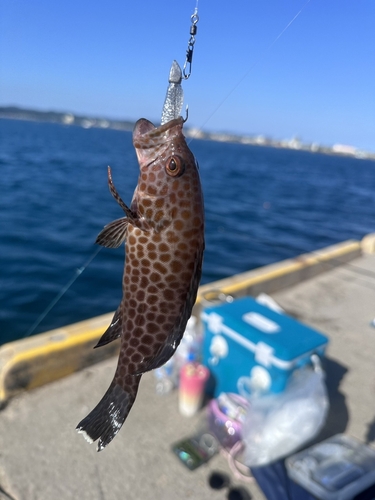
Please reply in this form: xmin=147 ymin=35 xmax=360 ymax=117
xmin=77 ymin=118 xmax=204 ymax=450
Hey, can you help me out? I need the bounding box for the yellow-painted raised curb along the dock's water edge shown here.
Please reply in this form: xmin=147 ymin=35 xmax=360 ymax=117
xmin=0 ymin=240 xmax=361 ymax=406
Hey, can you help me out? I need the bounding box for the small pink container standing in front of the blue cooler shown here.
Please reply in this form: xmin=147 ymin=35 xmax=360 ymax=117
xmin=179 ymin=363 xmax=209 ymax=417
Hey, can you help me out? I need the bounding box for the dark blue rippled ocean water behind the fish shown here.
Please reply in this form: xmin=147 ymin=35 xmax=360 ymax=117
xmin=0 ymin=120 xmax=375 ymax=343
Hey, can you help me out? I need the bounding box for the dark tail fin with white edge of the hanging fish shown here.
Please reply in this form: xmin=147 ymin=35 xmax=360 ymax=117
xmin=76 ymin=376 xmax=141 ymax=451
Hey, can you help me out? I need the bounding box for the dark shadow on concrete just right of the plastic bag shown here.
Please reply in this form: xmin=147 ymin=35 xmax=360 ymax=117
xmin=314 ymin=357 xmax=349 ymax=442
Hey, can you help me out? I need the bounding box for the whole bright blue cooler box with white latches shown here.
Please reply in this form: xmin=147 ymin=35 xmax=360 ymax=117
xmin=202 ymin=297 xmax=328 ymax=397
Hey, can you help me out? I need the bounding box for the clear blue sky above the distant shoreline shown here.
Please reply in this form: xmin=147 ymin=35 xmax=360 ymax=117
xmin=0 ymin=0 xmax=375 ymax=151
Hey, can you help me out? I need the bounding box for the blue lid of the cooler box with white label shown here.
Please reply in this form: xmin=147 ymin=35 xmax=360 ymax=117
xmin=202 ymin=297 xmax=328 ymax=369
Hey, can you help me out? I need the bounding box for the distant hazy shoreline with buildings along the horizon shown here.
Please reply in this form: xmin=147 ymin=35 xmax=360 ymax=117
xmin=0 ymin=106 xmax=375 ymax=160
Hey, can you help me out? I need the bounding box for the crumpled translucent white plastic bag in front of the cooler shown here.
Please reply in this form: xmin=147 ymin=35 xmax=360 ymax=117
xmin=242 ymin=368 xmax=329 ymax=467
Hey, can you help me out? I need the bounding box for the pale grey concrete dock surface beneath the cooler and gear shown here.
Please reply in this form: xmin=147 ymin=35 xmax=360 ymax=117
xmin=0 ymin=254 xmax=375 ymax=500
